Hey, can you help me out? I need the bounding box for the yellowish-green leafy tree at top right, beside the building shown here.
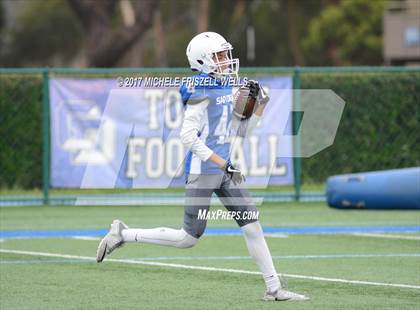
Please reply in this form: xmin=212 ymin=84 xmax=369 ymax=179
xmin=303 ymin=0 xmax=385 ymax=66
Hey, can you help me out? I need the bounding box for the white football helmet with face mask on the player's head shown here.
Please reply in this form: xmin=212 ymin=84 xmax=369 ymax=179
xmin=187 ymin=32 xmax=239 ymax=77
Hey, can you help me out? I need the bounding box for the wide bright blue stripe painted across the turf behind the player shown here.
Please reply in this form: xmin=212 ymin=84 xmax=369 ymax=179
xmin=0 ymin=225 xmax=420 ymax=238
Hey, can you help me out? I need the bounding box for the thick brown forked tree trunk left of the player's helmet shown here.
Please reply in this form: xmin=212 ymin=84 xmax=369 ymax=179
xmin=68 ymin=0 xmax=159 ymax=67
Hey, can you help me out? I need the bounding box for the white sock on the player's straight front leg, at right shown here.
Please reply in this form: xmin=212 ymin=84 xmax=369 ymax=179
xmin=241 ymin=222 xmax=280 ymax=292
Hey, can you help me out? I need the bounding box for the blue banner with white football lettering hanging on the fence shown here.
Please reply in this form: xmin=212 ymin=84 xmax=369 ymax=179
xmin=49 ymin=77 xmax=293 ymax=188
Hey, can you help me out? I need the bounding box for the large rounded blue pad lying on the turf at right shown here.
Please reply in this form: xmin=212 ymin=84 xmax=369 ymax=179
xmin=326 ymin=167 xmax=420 ymax=209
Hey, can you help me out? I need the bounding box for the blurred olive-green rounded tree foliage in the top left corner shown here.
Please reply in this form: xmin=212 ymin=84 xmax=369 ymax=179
xmin=0 ymin=0 xmax=83 ymax=67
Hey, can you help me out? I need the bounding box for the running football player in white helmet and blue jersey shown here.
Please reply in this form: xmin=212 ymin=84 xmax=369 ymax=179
xmin=97 ymin=32 xmax=308 ymax=300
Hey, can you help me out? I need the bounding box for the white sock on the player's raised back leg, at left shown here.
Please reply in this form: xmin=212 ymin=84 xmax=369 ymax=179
xmin=122 ymin=227 xmax=198 ymax=248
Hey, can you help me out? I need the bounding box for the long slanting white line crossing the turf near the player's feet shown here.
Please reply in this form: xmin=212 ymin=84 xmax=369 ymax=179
xmin=0 ymin=249 xmax=420 ymax=289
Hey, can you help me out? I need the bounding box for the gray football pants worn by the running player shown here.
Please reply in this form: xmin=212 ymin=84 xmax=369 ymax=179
xmin=184 ymin=174 xmax=257 ymax=238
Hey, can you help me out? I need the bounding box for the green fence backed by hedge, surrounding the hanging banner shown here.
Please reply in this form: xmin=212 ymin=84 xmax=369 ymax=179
xmin=0 ymin=67 xmax=420 ymax=205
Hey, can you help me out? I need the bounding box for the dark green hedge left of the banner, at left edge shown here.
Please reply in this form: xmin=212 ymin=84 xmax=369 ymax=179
xmin=0 ymin=74 xmax=42 ymax=188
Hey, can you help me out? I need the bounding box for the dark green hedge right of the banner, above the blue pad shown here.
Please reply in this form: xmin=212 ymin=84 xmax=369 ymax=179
xmin=301 ymin=72 xmax=420 ymax=183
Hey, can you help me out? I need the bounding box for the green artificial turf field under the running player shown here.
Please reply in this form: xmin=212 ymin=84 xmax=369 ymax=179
xmin=0 ymin=203 xmax=420 ymax=310
